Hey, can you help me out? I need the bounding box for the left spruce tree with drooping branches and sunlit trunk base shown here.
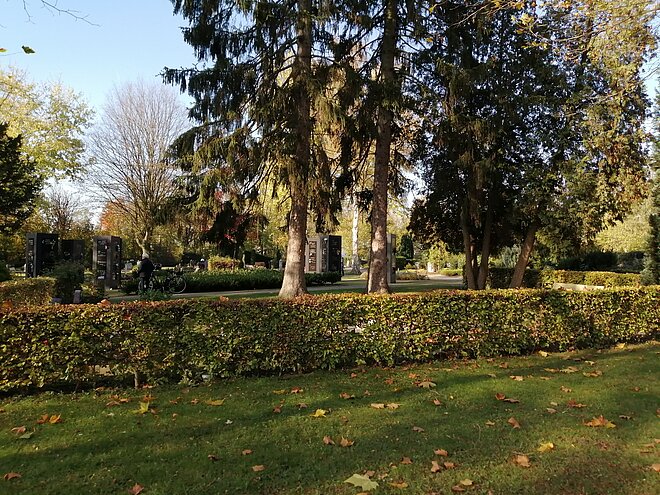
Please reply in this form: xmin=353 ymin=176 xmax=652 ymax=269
xmin=165 ymin=0 xmax=342 ymax=297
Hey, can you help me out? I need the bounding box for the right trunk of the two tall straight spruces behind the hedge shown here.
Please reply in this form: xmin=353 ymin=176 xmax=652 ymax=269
xmin=367 ymin=0 xmax=397 ymax=293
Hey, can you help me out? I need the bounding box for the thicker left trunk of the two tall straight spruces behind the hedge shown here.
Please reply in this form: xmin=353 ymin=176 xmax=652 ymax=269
xmin=279 ymin=0 xmax=312 ymax=298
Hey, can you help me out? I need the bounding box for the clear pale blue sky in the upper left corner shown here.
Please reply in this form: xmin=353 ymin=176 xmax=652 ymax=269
xmin=0 ymin=0 xmax=195 ymax=109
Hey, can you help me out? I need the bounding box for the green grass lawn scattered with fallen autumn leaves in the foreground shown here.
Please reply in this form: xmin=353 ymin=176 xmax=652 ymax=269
xmin=0 ymin=343 xmax=660 ymax=495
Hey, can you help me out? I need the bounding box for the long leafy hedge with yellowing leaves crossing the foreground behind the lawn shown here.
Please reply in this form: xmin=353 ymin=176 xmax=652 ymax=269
xmin=0 ymin=287 xmax=660 ymax=391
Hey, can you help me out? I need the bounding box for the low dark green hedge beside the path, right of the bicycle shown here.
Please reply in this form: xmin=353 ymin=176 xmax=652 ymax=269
xmin=122 ymin=270 xmax=341 ymax=294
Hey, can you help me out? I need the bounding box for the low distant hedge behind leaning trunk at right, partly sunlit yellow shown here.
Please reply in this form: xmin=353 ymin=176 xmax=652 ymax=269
xmin=489 ymin=268 xmax=640 ymax=289
